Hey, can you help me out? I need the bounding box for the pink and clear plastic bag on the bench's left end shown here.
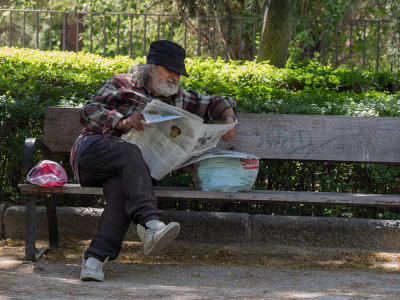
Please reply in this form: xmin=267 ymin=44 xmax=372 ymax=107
xmin=26 ymin=160 xmax=68 ymax=186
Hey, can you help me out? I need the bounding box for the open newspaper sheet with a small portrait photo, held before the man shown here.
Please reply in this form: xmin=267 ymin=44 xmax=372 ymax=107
xmin=121 ymin=100 xmax=236 ymax=180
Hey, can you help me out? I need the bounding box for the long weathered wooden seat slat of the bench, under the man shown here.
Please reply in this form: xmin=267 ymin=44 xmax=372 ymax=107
xmin=19 ymin=184 xmax=400 ymax=207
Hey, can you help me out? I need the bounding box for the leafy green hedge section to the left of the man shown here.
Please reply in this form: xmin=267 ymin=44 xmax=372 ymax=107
xmin=0 ymin=48 xmax=141 ymax=198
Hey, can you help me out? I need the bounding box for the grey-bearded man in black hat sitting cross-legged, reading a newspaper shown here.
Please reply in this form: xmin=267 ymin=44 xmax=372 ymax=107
xmin=71 ymin=40 xmax=236 ymax=281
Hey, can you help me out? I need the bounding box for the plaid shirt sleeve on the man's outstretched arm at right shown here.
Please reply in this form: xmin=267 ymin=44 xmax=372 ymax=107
xmin=184 ymin=90 xmax=236 ymax=123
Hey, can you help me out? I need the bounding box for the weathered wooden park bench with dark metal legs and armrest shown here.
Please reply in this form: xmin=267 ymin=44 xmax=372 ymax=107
xmin=19 ymin=107 xmax=400 ymax=260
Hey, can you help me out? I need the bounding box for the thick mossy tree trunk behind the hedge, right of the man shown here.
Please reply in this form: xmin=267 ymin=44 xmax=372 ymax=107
xmin=258 ymin=0 xmax=296 ymax=68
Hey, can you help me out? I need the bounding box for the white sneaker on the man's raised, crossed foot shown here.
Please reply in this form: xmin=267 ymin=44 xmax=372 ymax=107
xmin=137 ymin=220 xmax=181 ymax=255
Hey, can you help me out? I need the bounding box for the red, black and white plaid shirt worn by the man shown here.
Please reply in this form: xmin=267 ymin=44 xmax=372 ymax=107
xmin=71 ymin=74 xmax=236 ymax=181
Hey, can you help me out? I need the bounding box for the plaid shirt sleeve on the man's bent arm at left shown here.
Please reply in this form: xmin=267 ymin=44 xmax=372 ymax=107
xmin=80 ymin=77 xmax=124 ymax=134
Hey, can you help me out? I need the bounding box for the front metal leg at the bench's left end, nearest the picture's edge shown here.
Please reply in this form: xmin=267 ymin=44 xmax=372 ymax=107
xmin=25 ymin=195 xmax=36 ymax=261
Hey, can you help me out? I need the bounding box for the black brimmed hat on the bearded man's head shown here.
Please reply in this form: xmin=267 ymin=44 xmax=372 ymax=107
xmin=147 ymin=40 xmax=189 ymax=77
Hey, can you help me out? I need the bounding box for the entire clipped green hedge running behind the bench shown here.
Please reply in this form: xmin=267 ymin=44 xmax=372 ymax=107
xmin=0 ymin=47 xmax=400 ymax=218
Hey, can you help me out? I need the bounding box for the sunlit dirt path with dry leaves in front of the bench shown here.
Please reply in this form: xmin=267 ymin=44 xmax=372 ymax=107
xmin=0 ymin=240 xmax=400 ymax=299
